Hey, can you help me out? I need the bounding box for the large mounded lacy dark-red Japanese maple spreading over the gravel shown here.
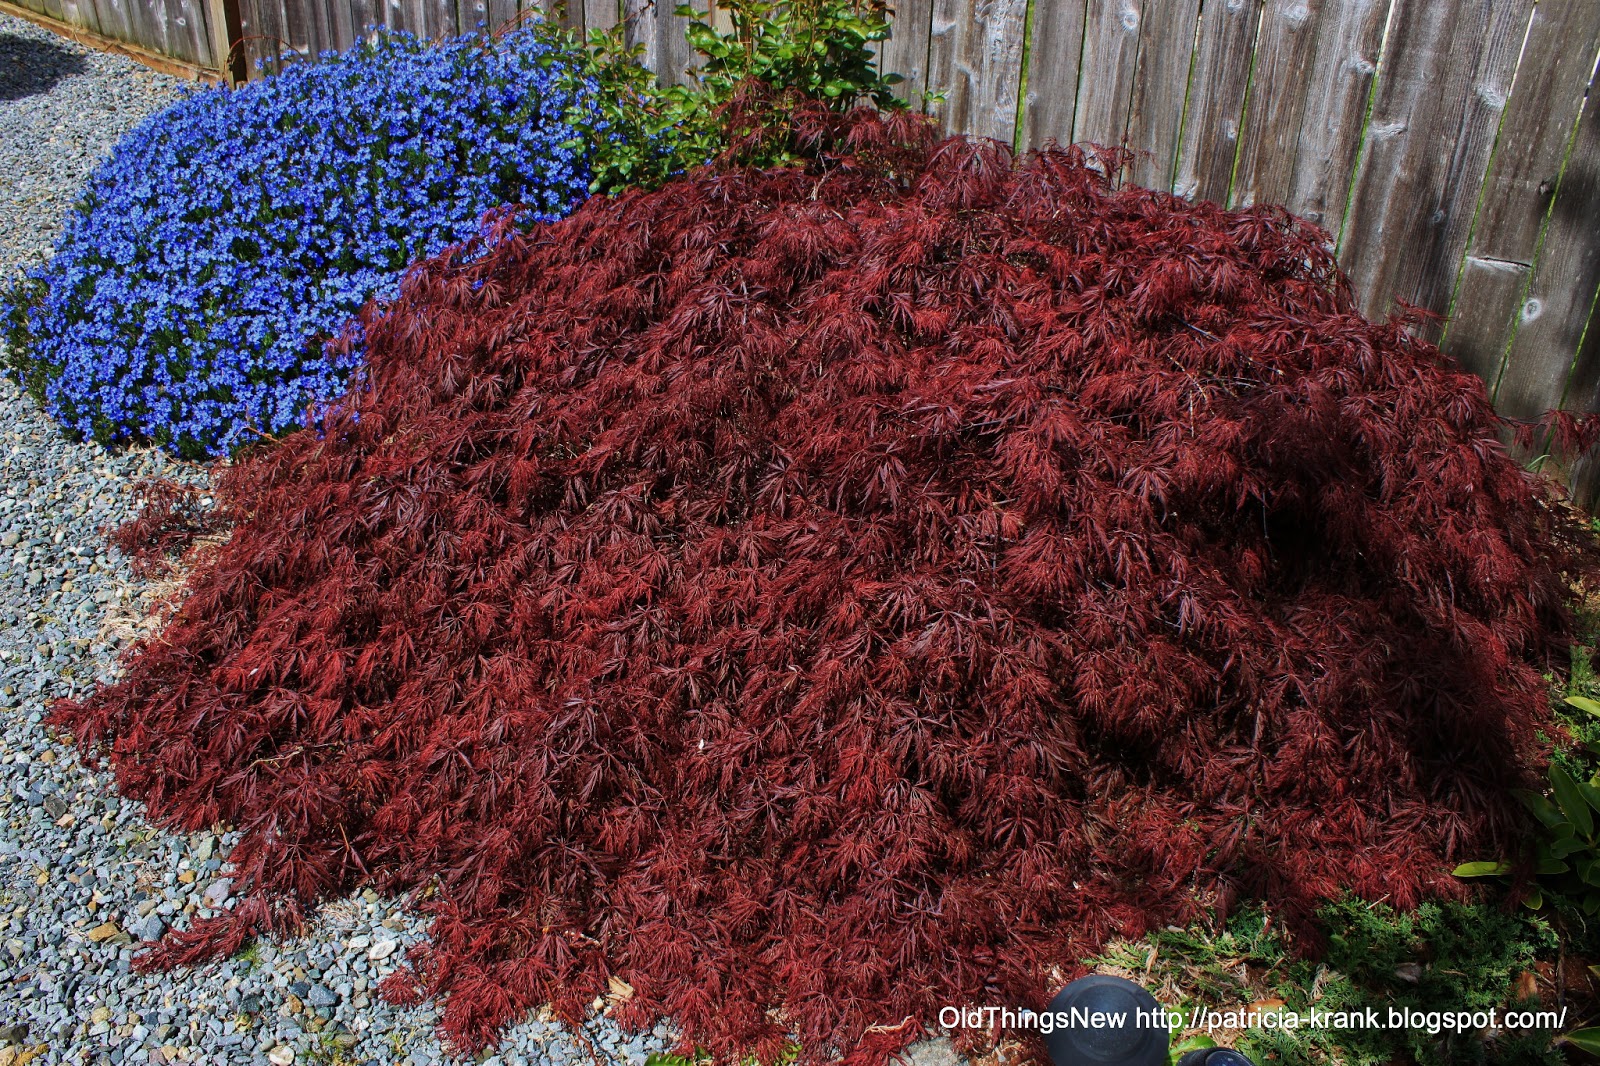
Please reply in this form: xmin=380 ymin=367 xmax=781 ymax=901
xmin=56 ymin=115 xmax=1565 ymax=1058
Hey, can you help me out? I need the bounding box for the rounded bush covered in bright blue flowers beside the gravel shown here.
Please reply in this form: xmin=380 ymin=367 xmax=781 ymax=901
xmin=3 ymin=26 xmax=597 ymax=458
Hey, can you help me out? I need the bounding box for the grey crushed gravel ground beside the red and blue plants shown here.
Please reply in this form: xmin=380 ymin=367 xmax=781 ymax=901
xmin=0 ymin=14 xmax=691 ymax=1066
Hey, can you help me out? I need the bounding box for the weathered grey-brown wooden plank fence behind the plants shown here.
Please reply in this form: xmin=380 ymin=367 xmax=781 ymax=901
xmin=9 ymin=0 xmax=1600 ymax=498
